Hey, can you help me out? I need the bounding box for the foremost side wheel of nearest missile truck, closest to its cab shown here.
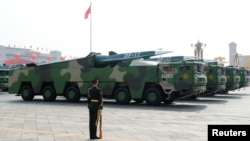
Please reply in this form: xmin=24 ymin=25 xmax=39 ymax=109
xmin=144 ymin=88 xmax=162 ymax=105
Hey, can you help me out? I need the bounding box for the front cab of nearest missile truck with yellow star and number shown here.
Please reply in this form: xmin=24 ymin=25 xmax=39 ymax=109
xmin=160 ymin=61 xmax=207 ymax=99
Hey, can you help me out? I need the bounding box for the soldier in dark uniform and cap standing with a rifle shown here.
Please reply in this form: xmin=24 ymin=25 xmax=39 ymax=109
xmin=88 ymin=78 xmax=103 ymax=139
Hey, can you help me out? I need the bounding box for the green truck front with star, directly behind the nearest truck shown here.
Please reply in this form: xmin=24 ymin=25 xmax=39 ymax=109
xmin=204 ymin=61 xmax=227 ymax=96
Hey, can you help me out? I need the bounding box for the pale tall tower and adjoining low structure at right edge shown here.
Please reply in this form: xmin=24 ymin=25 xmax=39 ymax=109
xmin=229 ymin=42 xmax=250 ymax=69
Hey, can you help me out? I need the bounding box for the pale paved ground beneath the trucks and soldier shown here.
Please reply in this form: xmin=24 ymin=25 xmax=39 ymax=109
xmin=0 ymin=88 xmax=250 ymax=141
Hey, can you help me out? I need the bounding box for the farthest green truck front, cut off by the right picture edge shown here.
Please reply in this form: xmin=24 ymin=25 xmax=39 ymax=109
xmin=240 ymin=67 xmax=250 ymax=88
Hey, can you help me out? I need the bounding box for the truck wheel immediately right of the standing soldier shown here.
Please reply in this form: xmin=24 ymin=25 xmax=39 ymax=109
xmin=115 ymin=87 xmax=131 ymax=104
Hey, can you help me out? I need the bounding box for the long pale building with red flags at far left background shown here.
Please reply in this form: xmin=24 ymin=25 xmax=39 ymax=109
xmin=0 ymin=45 xmax=65 ymax=65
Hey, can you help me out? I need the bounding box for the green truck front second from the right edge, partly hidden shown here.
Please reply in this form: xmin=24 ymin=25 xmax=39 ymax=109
xmin=221 ymin=66 xmax=240 ymax=94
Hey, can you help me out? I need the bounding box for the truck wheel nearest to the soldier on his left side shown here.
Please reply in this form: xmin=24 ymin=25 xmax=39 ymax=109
xmin=65 ymin=86 xmax=81 ymax=102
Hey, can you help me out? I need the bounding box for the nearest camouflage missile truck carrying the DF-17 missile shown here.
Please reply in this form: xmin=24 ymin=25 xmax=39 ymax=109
xmin=8 ymin=51 xmax=182 ymax=105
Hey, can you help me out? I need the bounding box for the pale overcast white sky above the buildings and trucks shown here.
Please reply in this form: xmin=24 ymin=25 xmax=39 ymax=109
xmin=0 ymin=0 xmax=250 ymax=60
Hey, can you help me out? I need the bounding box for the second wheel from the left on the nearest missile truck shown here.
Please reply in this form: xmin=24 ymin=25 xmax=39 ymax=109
xmin=42 ymin=86 xmax=56 ymax=101
